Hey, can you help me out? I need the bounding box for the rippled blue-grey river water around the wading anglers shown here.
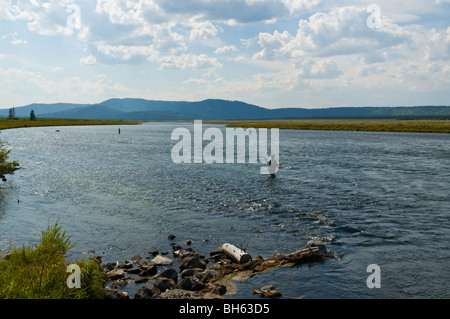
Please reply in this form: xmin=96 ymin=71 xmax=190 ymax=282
xmin=0 ymin=123 xmax=450 ymax=298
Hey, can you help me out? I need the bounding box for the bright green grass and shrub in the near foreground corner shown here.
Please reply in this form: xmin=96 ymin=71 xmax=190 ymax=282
xmin=0 ymin=223 xmax=106 ymax=299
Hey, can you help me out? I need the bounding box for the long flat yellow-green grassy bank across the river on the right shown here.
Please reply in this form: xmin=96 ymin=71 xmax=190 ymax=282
xmin=214 ymin=119 xmax=450 ymax=133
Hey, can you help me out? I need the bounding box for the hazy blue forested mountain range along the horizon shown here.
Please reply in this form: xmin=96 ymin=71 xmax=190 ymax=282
xmin=0 ymin=98 xmax=450 ymax=121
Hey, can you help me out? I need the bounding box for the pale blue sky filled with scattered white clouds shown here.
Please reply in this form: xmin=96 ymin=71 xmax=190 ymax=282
xmin=0 ymin=0 xmax=450 ymax=108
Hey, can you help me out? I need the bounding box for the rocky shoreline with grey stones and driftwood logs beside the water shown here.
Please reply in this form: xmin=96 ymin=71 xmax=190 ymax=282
xmin=95 ymin=235 xmax=330 ymax=299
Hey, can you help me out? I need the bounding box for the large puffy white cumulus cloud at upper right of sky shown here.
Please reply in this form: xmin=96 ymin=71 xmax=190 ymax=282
xmin=255 ymin=7 xmax=412 ymax=59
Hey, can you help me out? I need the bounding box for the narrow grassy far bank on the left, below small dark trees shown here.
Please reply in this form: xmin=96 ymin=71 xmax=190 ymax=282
xmin=0 ymin=118 xmax=141 ymax=130
